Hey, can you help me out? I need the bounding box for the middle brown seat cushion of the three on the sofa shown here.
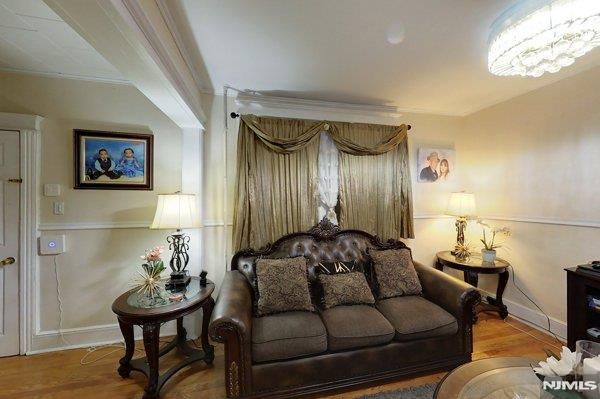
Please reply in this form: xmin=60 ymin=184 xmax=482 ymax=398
xmin=321 ymin=305 xmax=394 ymax=351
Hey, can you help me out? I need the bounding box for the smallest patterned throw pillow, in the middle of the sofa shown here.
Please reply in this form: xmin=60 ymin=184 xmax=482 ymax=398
xmin=319 ymin=272 xmax=375 ymax=309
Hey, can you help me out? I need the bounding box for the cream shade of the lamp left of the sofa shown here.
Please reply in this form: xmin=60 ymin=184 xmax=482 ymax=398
xmin=150 ymin=194 xmax=201 ymax=230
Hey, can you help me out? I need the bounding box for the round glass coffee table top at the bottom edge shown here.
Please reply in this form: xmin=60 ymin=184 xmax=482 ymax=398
xmin=458 ymin=367 xmax=553 ymax=399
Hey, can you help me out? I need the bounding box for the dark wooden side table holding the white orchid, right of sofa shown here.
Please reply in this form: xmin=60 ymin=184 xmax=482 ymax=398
xmin=435 ymin=251 xmax=510 ymax=322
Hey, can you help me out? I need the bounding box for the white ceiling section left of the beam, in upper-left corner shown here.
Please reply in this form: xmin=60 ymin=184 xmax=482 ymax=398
xmin=0 ymin=0 xmax=125 ymax=82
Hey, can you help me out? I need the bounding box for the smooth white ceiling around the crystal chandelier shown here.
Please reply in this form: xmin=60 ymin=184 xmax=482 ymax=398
xmin=179 ymin=0 xmax=600 ymax=115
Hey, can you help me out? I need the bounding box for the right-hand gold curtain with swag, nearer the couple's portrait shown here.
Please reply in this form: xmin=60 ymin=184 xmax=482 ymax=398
xmin=336 ymin=122 xmax=414 ymax=240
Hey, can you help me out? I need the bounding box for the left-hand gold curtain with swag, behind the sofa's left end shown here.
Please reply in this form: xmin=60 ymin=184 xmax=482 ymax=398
xmin=233 ymin=116 xmax=319 ymax=250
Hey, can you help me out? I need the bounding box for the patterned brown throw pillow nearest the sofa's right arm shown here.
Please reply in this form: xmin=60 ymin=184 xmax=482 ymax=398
xmin=369 ymin=249 xmax=422 ymax=299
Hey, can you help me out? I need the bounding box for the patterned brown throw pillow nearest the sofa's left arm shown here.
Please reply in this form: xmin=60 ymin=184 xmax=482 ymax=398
xmin=256 ymin=257 xmax=315 ymax=316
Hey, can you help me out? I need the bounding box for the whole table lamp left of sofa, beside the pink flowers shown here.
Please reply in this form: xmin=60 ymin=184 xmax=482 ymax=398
xmin=150 ymin=193 xmax=200 ymax=291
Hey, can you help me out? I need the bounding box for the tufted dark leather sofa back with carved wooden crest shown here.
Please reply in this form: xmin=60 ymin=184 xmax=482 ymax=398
xmin=231 ymin=221 xmax=407 ymax=285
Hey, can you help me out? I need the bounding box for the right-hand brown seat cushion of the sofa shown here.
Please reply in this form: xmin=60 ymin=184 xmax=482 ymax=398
xmin=376 ymin=296 xmax=458 ymax=341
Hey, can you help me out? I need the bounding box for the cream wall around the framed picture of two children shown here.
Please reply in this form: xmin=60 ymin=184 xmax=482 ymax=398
xmin=0 ymin=73 xmax=192 ymax=351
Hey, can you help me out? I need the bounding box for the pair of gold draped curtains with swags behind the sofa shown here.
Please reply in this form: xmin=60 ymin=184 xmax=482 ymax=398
xmin=233 ymin=115 xmax=413 ymax=250
